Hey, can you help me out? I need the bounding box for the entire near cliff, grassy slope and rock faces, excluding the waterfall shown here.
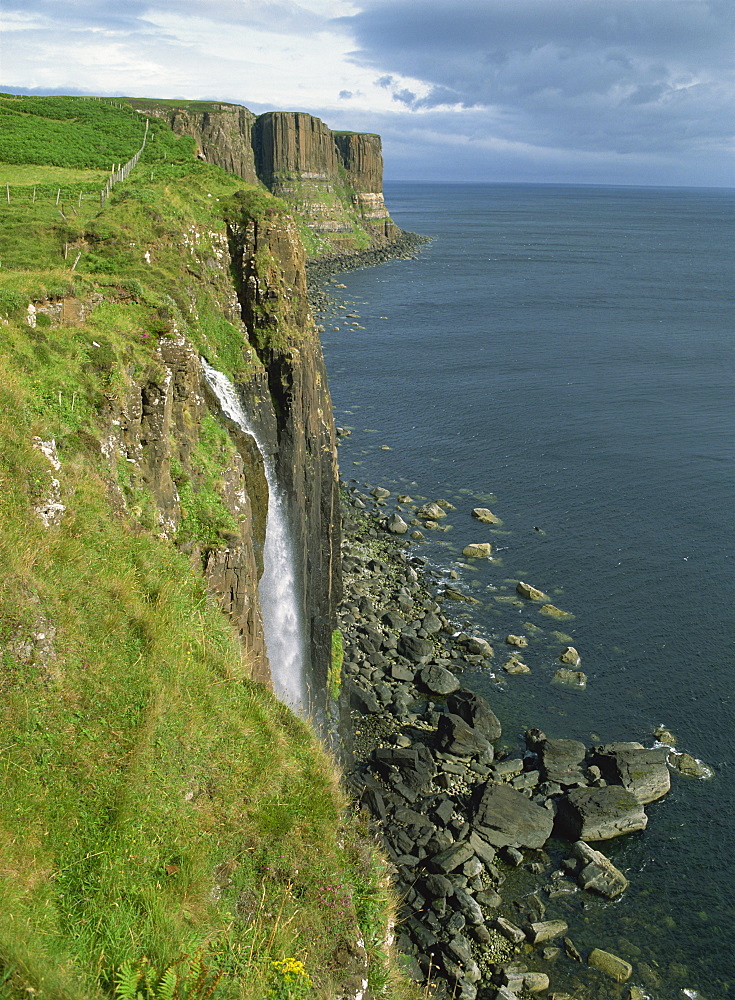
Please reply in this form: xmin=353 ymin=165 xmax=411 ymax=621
xmin=0 ymin=98 xmax=416 ymax=1000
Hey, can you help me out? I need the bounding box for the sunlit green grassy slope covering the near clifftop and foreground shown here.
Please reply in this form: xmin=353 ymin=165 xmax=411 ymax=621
xmin=0 ymin=99 xmax=420 ymax=1000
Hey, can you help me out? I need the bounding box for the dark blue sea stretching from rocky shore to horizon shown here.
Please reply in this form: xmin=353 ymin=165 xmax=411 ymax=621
xmin=322 ymin=183 xmax=735 ymax=1000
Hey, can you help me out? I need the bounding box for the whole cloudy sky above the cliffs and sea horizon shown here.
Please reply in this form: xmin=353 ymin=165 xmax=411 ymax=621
xmin=0 ymin=0 xmax=735 ymax=187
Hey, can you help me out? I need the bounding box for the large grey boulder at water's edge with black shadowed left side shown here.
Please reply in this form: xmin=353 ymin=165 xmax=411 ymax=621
xmin=556 ymin=785 xmax=648 ymax=840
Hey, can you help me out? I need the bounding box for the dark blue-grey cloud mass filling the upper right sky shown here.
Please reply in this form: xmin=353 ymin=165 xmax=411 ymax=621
xmin=343 ymin=0 xmax=735 ymax=155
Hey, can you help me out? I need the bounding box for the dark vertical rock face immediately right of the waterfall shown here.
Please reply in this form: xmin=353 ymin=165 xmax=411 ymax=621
xmin=228 ymin=198 xmax=341 ymax=715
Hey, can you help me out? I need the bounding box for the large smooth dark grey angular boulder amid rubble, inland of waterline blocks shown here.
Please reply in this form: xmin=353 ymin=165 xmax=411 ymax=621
xmin=472 ymin=781 xmax=556 ymax=848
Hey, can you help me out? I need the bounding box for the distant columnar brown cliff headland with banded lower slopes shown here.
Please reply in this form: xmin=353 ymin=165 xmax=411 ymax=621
xmin=131 ymin=99 xmax=401 ymax=257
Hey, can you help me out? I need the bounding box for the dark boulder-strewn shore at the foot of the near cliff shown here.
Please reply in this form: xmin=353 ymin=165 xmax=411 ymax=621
xmin=340 ymin=487 xmax=708 ymax=1000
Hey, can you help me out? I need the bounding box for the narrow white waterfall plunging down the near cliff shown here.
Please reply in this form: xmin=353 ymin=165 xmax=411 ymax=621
xmin=202 ymin=358 xmax=307 ymax=715
